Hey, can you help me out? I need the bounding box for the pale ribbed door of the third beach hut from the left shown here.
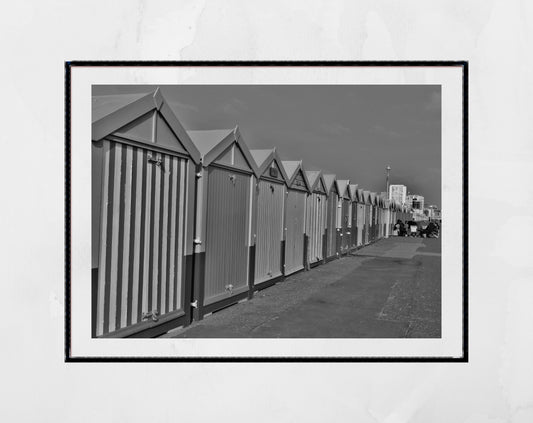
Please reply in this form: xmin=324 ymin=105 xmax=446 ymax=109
xmin=254 ymin=181 xmax=285 ymax=284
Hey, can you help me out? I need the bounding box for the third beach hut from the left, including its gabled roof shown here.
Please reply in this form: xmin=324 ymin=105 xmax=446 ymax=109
xmin=250 ymin=148 xmax=289 ymax=288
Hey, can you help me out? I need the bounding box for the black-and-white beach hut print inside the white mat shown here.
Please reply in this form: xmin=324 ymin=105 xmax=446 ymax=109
xmin=90 ymin=84 xmax=440 ymax=340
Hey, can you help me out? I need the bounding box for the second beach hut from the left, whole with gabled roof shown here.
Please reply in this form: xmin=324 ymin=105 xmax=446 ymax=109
xmin=187 ymin=127 xmax=257 ymax=319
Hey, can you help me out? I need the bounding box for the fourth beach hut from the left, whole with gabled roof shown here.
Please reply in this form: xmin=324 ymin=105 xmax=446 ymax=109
xmin=282 ymin=160 xmax=310 ymax=275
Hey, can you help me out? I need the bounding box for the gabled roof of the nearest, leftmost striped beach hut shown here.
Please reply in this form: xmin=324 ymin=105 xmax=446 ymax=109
xmin=91 ymin=88 xmax=200 ymax=163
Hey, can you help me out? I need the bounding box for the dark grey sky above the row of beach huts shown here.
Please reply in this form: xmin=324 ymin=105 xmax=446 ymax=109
xmin=93 ymin=85 xmax=441 ymax=206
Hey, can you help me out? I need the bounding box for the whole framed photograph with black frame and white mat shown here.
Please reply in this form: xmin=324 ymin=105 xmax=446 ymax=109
xmin=65 ymin=61 xmax=468 ymax=362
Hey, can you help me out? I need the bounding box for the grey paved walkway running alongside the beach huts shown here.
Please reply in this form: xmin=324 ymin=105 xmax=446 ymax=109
xmin=167 ymin=238 xmax=441 ymax=338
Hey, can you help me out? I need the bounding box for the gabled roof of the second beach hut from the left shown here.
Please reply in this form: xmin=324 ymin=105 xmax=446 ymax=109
xmin=187 ymin=126 xmax=258 ymax=176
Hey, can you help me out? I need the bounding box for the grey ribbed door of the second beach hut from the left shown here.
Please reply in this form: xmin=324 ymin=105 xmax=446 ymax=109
xmin=204 ymin=167 xmax=250 ymax=305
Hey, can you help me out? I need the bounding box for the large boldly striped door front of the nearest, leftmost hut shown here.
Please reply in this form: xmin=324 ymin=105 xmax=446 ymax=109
xmin=96 ymin=140 xmax=187 ymax=336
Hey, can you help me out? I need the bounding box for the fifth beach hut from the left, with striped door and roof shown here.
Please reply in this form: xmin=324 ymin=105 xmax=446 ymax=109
xmin=305 ymin=170 xmax=327 ymax=267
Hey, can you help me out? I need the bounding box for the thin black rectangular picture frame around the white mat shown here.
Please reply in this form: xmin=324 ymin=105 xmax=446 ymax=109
xmin=64 ymin=60 xmax=469 ymax=363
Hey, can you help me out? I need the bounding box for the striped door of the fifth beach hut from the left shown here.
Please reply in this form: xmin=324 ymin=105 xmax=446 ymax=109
xmin=307 ymin=193 xmax=327 ymax=263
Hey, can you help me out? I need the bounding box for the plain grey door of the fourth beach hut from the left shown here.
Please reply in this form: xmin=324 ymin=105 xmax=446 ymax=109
xmin=285 ymin=190 xmax=306 ymax=275
